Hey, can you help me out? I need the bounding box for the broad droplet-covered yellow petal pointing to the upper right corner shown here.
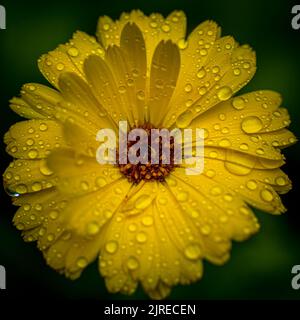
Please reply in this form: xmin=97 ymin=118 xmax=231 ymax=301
xmin=164 ymin=31 xmax=256 ymax=127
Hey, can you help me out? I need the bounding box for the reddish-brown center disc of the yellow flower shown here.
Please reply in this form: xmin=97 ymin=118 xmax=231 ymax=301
xmin=117 ymin=123 xmax=177 ymax=183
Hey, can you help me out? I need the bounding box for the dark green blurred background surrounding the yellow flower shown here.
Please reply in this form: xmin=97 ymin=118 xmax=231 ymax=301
xmin=0 ymin=0 xmax=300 ymax=300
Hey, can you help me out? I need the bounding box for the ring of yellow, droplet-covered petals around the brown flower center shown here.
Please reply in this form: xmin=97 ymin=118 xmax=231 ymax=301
xmin=4 ymin=11 xmax=296 ymax=298
